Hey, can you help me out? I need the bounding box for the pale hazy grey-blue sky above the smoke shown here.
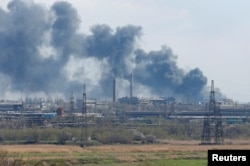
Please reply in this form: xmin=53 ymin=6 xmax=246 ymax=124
xmin=0 ymin=0 xmax=250 ymax=102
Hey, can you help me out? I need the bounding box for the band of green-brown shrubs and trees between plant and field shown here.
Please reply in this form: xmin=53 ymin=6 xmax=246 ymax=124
xmin=0 ymin=122 xmax=250 ymax=145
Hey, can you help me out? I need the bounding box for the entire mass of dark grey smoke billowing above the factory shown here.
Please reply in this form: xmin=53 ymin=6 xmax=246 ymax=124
xmin=0 ymin=0 xmax=207 ymax=99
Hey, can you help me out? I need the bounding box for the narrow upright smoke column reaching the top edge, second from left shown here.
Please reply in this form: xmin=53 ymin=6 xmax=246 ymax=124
xmin=51 ymin=2 xmax=83 ymax=56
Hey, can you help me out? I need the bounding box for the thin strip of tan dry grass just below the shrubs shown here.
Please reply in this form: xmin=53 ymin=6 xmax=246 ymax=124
xmin=0 ymin=141 xmax=250 ymax=153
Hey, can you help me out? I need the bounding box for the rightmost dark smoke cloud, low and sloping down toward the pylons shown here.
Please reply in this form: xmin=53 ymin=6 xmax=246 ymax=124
xmin=134 ymin=47 xmax=207 ymax=99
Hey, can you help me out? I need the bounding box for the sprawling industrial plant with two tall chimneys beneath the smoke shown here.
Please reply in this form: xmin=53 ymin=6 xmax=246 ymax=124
xmin=0 ymin=74 xmax=250 ymax=131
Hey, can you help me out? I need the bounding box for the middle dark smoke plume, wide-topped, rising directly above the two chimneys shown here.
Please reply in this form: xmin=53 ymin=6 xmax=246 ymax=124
xmin=87 ymin=25 xmax=141 ymax=77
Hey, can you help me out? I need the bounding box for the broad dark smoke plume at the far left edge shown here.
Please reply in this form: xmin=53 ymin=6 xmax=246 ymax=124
xmin=0 ymin=1 xmax=49 ymax=91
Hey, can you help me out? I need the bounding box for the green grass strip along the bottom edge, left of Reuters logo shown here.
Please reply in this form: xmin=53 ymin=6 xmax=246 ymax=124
xmin=3 ymin=151 xmax=207 ymax=166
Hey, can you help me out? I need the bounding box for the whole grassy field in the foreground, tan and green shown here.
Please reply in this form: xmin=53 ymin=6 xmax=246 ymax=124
xmin=0 ymin=141 xmax=250 ymax=166
